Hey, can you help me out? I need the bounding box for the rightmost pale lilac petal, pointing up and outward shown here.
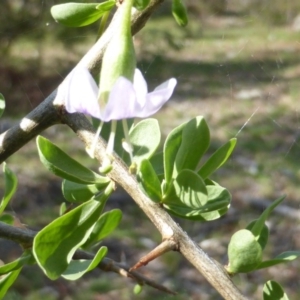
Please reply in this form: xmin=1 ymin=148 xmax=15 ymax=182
xmin=135 ymin=78 xmax=177 ymax=118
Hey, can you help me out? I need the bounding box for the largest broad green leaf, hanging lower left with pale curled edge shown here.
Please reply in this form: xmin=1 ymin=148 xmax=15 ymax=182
xmin=33 ymin=185 xmax=113 ymax=280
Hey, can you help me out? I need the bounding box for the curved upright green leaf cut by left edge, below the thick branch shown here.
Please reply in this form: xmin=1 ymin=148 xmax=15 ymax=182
xmin=0 ymin=162 xmax=18 ymax=214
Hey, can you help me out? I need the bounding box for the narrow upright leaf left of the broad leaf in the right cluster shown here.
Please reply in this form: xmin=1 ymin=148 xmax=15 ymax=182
xmin=164 ymin=123 xmax=187 ymax=185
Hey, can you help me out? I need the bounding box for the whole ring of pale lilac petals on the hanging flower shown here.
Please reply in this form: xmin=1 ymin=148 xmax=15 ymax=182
xmin=66 ymin=67 xmax=177 ymax=122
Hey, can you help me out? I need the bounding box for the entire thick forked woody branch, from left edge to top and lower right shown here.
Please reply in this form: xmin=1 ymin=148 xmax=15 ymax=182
xmin=0 ymin=0 xmax=246 ymax=300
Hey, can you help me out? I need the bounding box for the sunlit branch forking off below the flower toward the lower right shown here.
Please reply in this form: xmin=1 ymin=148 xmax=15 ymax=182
xmin=64 ymin=114 xmax=246 ymax=300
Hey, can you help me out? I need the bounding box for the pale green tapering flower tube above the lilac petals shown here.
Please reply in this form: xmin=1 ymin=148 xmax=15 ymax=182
xmin=99 ymin=0 xmax=136 ymax=108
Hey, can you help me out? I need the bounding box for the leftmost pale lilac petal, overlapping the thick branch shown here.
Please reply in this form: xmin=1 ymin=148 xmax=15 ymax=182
xmin=65 ymin=67 xmax=101 ymax=119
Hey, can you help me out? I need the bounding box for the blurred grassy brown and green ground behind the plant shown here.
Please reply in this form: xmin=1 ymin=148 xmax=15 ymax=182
xmin=0 ymin=0 xmax=300 ymax=300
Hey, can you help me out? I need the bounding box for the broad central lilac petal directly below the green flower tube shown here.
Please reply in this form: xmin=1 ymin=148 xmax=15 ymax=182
xmin=102 ymin=77 xmax=137 ymax=122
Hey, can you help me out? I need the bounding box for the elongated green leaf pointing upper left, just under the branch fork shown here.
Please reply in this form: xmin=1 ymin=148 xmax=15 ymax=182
xmin=36 ymin=136 xmax=110 ymax=184
